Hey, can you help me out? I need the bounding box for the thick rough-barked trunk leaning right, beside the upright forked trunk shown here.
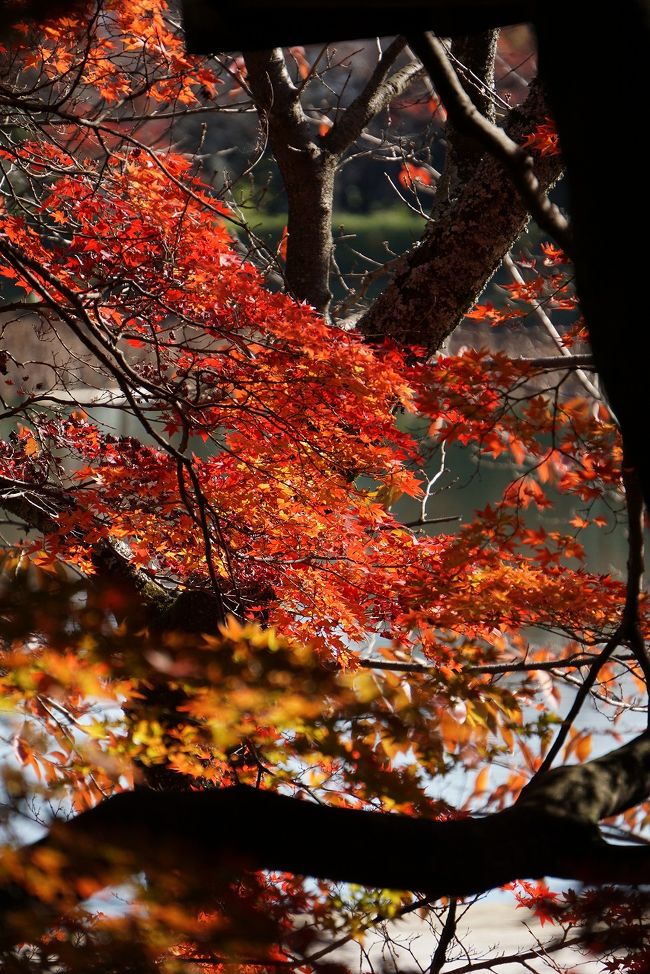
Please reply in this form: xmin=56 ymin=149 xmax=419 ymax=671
xmin=358 ymin=83 xmax=562 ymax=353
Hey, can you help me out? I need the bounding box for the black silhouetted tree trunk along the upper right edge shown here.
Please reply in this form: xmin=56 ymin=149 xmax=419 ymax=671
xmin=538 ymin=0 xmax=650 ymax=509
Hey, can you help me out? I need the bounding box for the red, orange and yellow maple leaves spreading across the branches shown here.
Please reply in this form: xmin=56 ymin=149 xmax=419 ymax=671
xmin=0 ymin=0 xmax=648 ymax=971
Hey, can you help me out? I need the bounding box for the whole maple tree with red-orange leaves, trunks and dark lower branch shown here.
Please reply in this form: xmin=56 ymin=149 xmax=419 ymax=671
xmin=0 ymin=0 xmax=650 ymax=972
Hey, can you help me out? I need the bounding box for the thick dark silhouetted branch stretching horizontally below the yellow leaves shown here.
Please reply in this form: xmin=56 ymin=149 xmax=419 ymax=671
xmin=0 ymin=733 xmax=650 ymax=947
